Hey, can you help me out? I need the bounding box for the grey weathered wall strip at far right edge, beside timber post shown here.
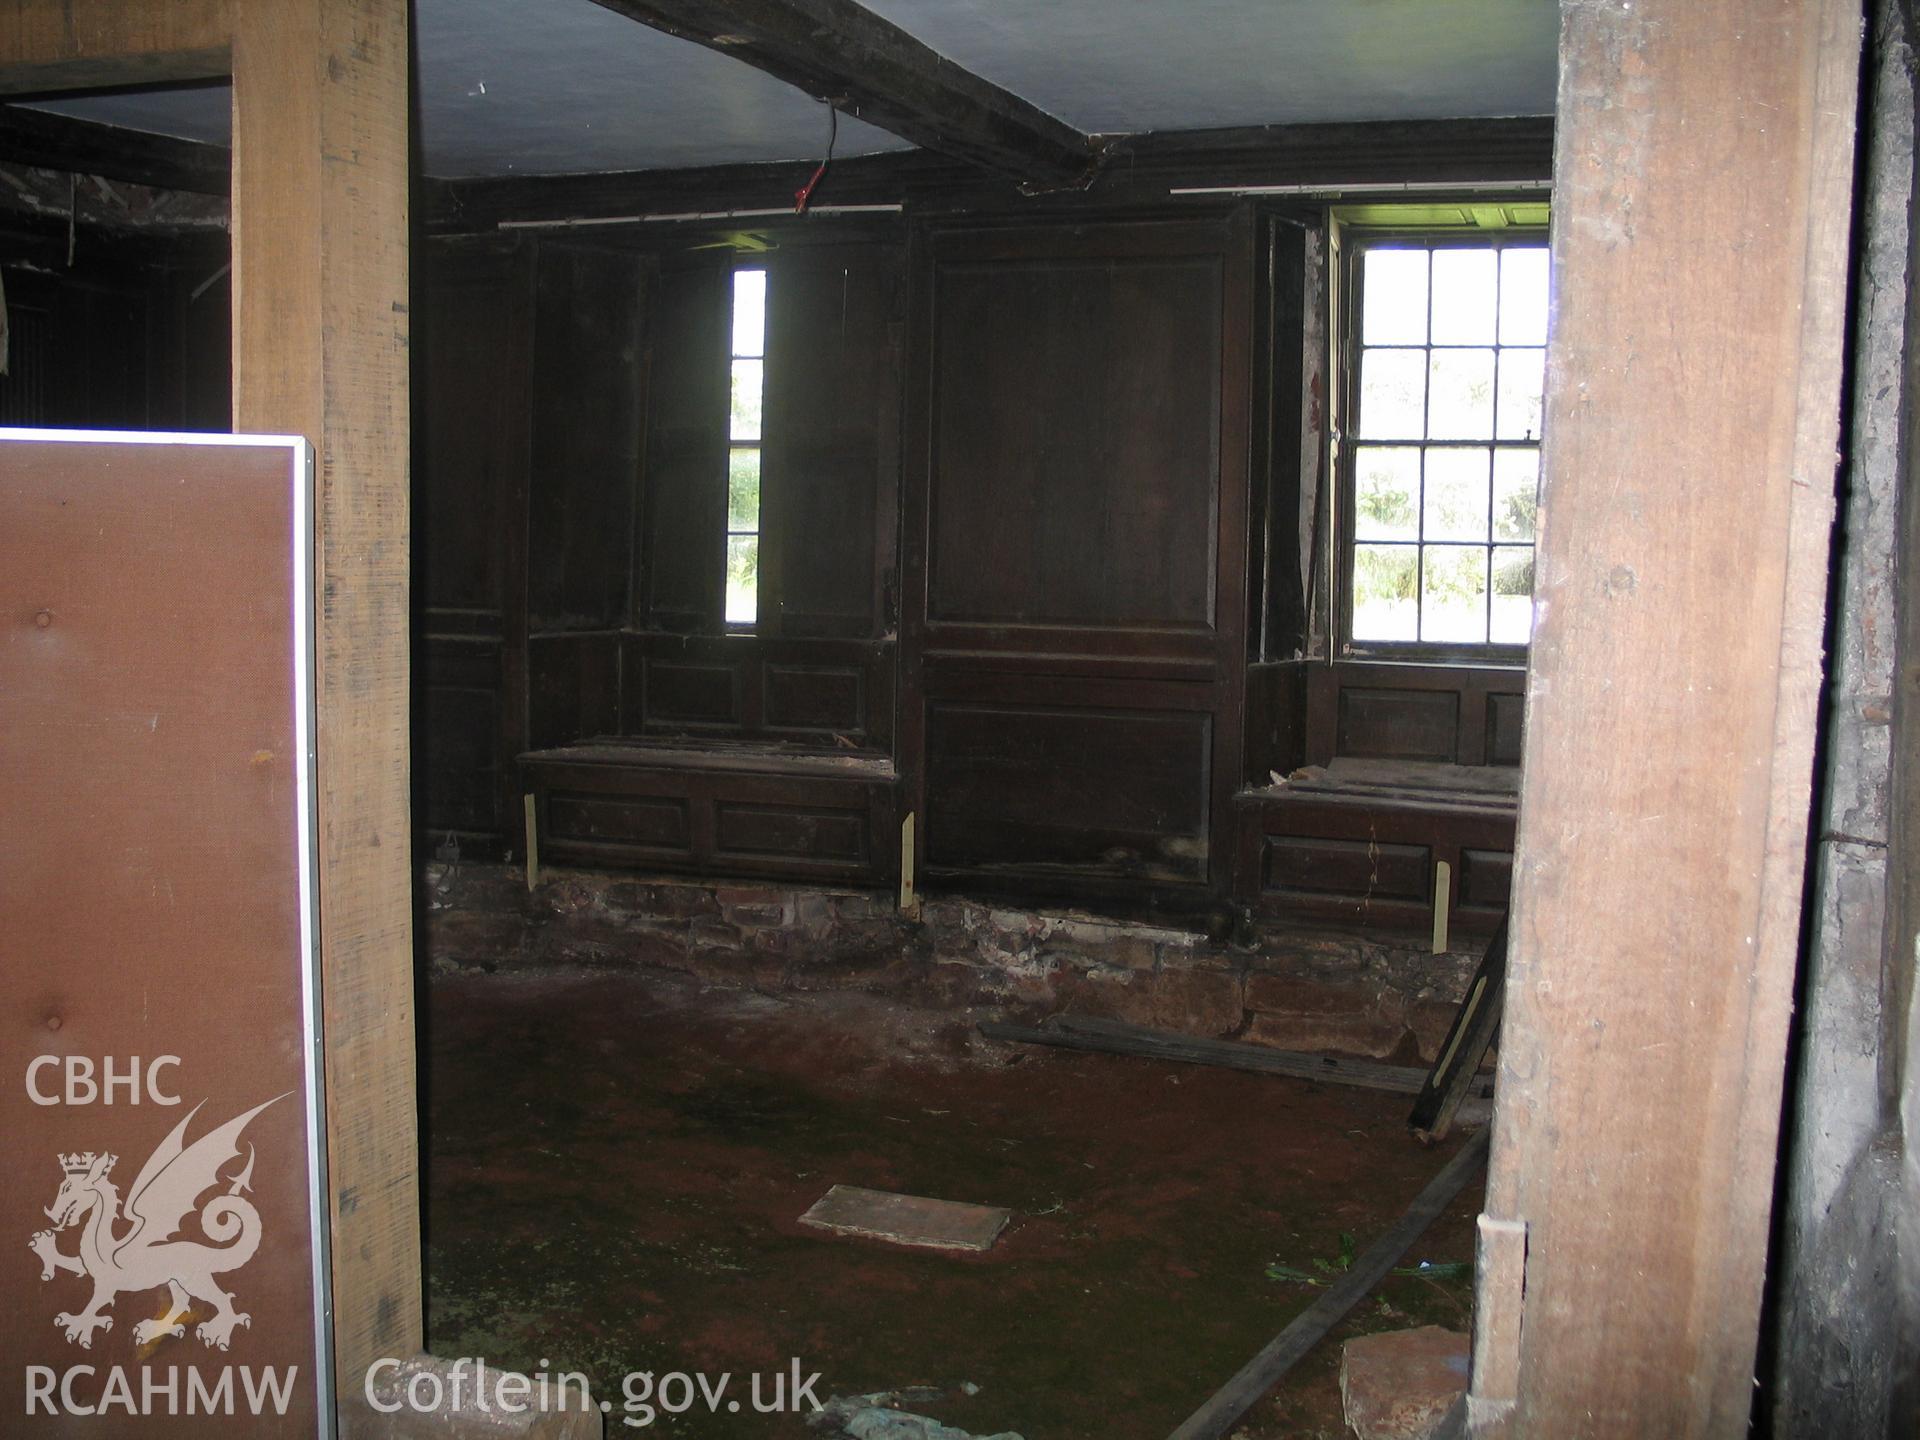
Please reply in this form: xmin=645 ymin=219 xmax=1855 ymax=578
xmin=1770 ymin=4 xmax=1914 ymax=1440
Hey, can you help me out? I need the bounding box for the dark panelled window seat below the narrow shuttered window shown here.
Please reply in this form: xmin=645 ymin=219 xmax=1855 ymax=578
xmin=520 ymin=735 xmax=899 ymax=885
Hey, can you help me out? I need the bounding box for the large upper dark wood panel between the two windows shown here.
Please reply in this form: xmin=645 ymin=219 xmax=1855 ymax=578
xmin=927 ymin=255 xmax=1223 ymax=630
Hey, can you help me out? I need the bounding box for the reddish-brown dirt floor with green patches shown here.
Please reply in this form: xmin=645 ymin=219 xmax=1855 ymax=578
xmin=424 ymin=972 xmax=1480 ymax=1440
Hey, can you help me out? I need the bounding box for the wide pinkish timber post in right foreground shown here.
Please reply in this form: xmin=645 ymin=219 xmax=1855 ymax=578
xmin=1469 ymin=0 xmax=1862 ymax=1440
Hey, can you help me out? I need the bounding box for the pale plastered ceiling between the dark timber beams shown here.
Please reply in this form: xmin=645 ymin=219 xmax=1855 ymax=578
xmin=30 ymin=0 xmax=1559 ymax=179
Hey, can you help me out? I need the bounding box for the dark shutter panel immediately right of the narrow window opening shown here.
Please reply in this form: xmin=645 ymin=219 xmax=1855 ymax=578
xmin=760 ymin=246 xmax=902 ymax=636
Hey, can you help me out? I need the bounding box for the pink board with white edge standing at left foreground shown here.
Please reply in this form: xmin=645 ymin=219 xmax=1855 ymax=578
xmin=0 ymin=430 xmax=332 ymax=1440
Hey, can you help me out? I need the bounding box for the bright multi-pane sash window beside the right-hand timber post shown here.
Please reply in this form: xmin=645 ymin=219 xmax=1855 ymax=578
xmin=1344 ymin=238 xmax=1548 ymax=651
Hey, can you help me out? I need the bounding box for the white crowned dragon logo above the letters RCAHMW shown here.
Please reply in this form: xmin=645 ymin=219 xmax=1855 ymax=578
xmin=27 ymin=1094 xmax=286 ymax=1350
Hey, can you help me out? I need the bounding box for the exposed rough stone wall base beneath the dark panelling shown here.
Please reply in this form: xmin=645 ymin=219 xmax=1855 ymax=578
xmin=424 ymin=864 xmax=1480 ymax=1064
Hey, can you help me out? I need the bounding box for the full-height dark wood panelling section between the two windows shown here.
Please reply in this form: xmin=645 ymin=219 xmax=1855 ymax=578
xmin=900 ymin=217 xmax=1254 ymax=906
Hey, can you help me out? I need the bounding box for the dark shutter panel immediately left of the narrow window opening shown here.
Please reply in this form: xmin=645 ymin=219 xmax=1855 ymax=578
xmin=639 ymin=255 xmax=730 ymax=634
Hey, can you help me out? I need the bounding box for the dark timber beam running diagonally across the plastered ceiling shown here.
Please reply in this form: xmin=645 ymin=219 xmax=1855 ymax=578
xmin=579 ymin=0 xmax=1098 ymax=190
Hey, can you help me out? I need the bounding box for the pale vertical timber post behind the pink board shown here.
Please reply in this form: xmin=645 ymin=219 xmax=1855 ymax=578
xmin=232 ymin=0 xmax=422 ymax=1388
